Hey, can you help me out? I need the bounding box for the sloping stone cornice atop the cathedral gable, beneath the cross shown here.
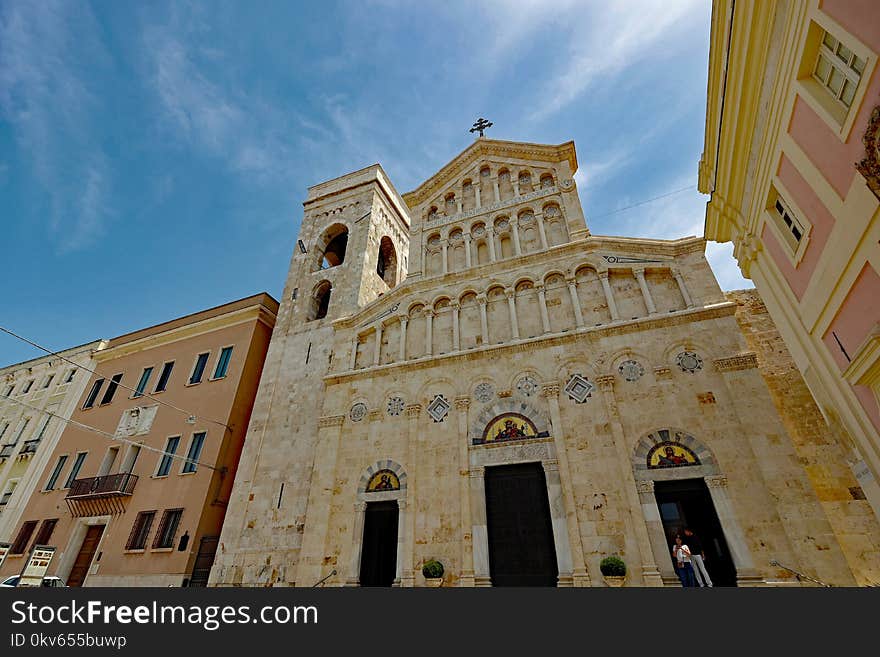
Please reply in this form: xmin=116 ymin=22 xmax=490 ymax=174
xmin=403 ymin=137 xmax=577 ymax=208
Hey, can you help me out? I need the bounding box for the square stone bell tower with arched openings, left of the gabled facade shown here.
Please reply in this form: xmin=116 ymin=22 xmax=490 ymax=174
xmin=211 ymin=164 xmax=409 ymax=586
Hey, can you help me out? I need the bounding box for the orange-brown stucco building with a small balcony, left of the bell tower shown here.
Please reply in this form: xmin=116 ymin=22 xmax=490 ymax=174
xmin=0 ymin=293 xmax=278 ymax=586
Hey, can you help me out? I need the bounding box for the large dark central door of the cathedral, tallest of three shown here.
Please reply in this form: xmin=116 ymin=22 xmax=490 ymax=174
xmin=486 ymin=463 xmax=559 ymax=586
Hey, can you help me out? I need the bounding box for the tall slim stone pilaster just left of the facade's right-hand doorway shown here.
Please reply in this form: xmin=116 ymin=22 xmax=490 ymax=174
xmin=596 ymin=375 xmax=663 ymax=586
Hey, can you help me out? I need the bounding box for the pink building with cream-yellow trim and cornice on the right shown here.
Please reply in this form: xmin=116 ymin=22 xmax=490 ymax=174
xmin=699 ymin=0 xmax=880 ymax=512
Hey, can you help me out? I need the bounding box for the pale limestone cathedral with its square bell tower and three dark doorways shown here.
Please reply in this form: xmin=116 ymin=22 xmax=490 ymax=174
xmin=210 ymin=137 xmax=880 ymax=586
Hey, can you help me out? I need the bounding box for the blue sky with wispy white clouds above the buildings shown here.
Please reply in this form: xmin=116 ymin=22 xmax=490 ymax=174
xmin=0 ymin=0 xmax=750 ymax=364
